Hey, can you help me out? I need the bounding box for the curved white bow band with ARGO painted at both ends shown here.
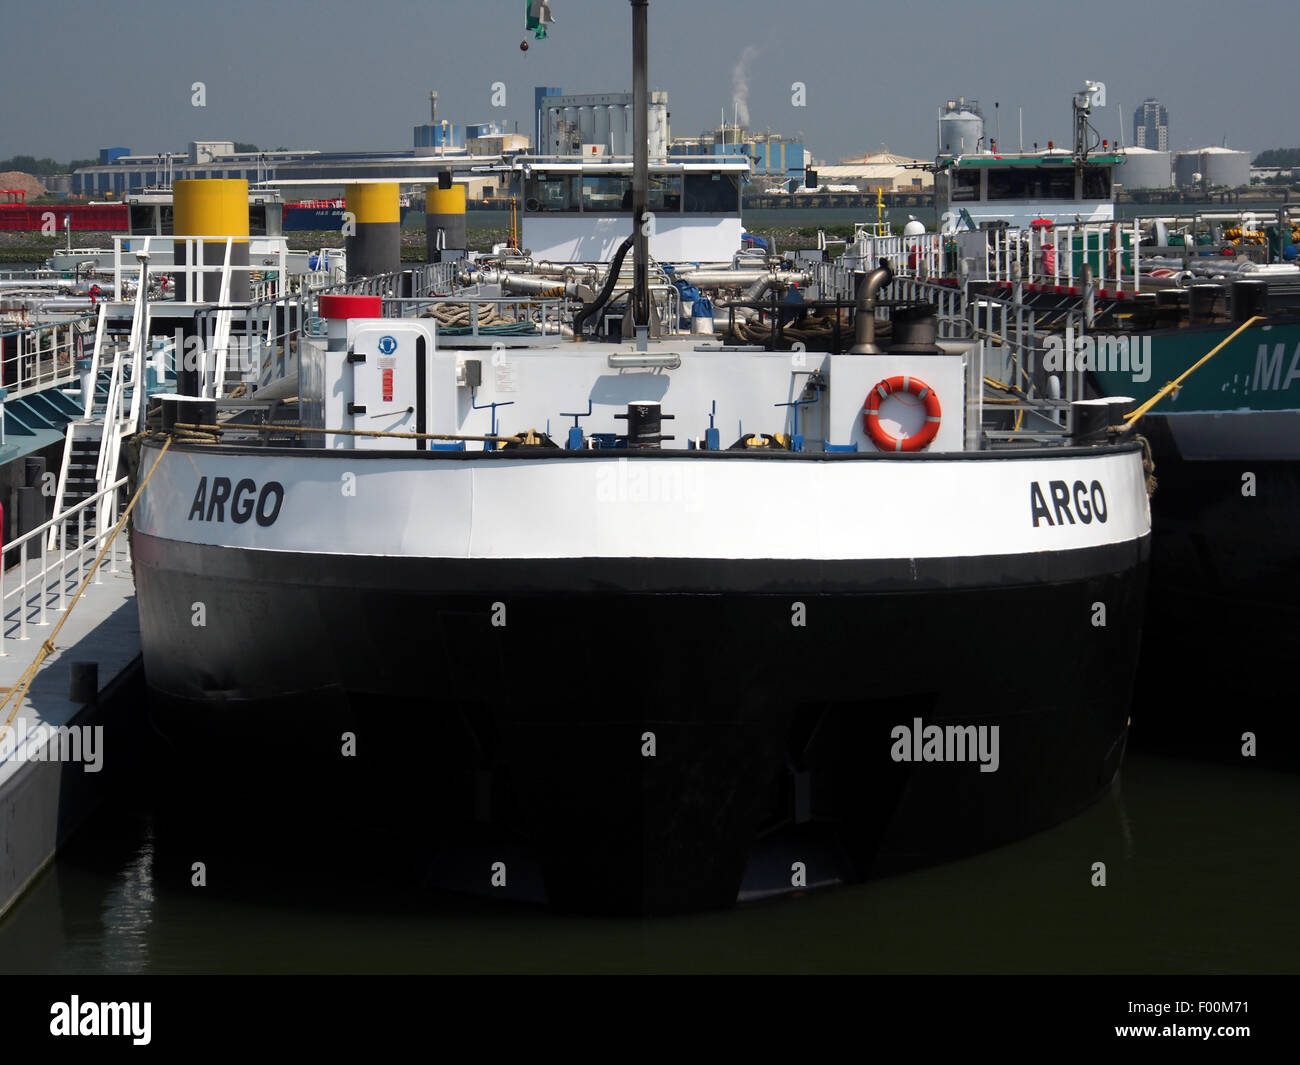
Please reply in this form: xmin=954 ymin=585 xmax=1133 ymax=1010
xmin=135 ymin=450 xmax=1151 ymax=559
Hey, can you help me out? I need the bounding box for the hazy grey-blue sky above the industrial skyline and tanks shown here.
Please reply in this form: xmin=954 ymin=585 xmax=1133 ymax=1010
xmin=0 ymin=0 xmax=1300 ymax=163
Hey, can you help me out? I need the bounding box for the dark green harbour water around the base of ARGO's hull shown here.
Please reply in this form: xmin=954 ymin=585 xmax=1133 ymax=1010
xmin=0 ymin=754 xmax=1300 ymax=974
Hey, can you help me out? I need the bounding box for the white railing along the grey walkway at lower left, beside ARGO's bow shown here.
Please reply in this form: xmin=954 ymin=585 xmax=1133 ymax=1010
xmin=0 ymin=477 xmax=130 ymax=657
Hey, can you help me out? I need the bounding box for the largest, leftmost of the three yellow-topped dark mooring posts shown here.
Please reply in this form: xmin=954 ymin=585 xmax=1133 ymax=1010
xmin=172 ymin=178 xmax=248 ymax=303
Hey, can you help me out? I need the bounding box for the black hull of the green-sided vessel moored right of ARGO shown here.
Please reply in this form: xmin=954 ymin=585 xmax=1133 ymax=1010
xmin=1134 ymin=417 xmax=1300 ymax=771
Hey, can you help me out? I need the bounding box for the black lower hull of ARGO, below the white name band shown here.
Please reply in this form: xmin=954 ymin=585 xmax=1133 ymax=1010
xmin=135 ymin=533 xmax=1148 ymax=913
